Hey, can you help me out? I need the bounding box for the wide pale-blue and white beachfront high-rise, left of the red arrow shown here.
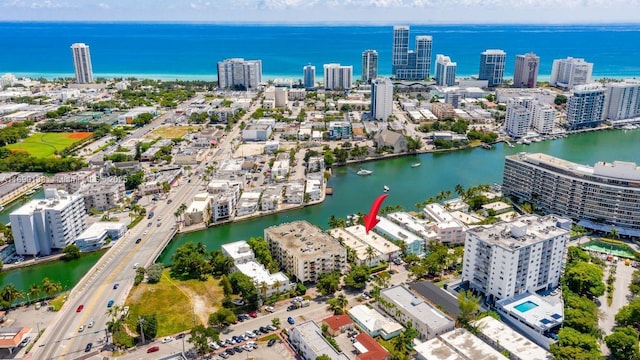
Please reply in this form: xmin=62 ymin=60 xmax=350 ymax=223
xmin=218 ymin=58 xmax=262 ymax=90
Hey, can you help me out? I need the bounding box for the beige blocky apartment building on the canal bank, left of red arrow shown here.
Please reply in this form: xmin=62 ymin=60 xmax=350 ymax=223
xmin=264 ymin=221 xmax=347 ymax=282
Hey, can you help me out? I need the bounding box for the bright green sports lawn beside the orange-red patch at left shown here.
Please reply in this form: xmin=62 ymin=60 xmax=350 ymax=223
xmin=7 ymin=132 xmax=92 ymax=158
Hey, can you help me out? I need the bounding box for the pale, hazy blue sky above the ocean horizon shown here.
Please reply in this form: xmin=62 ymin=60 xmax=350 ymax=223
xmin=0 ymin=0 xmax=640 ymax=24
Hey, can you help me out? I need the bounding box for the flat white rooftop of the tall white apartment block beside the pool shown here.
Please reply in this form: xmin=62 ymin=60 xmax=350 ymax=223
xmin=468 ymin=215 xmax=569 ymax=249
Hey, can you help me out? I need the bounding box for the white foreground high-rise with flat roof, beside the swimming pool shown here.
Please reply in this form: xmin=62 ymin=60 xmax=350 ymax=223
xmin=462 ymin=215 xmax=571 ymax=303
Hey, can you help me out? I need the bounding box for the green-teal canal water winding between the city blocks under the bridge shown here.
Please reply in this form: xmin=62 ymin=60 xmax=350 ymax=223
xmin=0 ymin=130 xmax=640 ymax=289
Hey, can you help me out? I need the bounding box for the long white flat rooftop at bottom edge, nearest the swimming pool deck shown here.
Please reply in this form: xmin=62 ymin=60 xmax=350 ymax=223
xmin=474 ymin=316 xmax=552 ymax=360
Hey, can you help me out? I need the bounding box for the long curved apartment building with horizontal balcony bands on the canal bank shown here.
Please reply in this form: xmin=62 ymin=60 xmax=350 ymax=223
xmin=502 ymin=153 xmax=640 ymax=236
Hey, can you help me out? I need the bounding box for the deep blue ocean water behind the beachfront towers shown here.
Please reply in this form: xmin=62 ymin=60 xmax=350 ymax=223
xmin=0 ymin=22 xmax=640 ymax=80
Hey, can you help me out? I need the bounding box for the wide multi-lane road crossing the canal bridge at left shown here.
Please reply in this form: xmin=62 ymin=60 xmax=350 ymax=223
xmin=33 ymin=97 xmax=257 ymax=359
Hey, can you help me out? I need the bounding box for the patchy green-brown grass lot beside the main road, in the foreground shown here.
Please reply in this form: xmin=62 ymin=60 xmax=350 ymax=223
xmin=125 ymin=269 xmax=224 ymax=338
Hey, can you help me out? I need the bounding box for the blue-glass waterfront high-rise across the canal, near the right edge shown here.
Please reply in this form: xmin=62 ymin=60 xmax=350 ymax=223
xmin=566 ymin=84 xmax=606 ymax=129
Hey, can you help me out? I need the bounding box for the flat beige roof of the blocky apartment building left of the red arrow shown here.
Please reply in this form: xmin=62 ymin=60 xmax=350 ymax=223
xmin=264 ymin=221 xmax=346 ymax=259
